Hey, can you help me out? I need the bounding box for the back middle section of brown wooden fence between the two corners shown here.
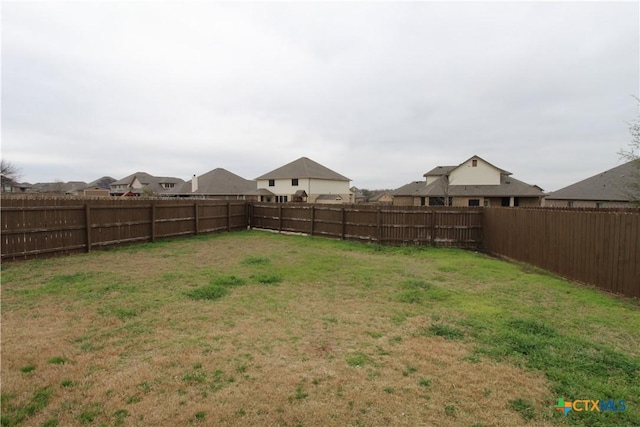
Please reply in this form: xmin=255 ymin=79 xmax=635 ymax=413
xmin=250 ymin=203 xmax=483 ymax=249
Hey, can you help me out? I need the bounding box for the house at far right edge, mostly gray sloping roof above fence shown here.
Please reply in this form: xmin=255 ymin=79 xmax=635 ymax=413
xmin=546 ymin=160 xmax=640 ymax=208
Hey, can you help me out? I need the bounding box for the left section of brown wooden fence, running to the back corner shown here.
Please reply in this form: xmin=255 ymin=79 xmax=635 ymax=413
xmin=1 ymin=198 xmax=249 ymax=260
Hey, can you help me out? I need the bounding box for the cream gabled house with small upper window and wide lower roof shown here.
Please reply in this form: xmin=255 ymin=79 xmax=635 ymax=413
xmin=393 ymin=156 xmax=544 ymax=206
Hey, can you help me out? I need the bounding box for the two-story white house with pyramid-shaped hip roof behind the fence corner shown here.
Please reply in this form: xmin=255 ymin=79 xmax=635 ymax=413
xmin=256 ymin=157 xmax=353 ymax=204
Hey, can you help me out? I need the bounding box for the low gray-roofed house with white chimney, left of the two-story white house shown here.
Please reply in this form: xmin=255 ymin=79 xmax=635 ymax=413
xmin=165 ymin=168 xmax=257 ymax=200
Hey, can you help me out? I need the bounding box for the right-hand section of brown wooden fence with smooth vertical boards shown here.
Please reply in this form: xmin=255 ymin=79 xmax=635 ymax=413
xmin=484 ymin=208 xmax=640 ymax=297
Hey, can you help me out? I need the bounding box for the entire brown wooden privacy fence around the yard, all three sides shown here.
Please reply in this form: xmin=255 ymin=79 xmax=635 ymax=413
xmin=0 ymin=197 xmax=640 ymax=297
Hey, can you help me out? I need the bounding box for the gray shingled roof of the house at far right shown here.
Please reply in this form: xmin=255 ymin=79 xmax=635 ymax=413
xmin=547 ymin=160 xmax=640 ymax=201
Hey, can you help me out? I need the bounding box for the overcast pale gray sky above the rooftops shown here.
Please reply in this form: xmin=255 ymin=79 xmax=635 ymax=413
xmin=1 ymin=1 xmax=640 ymax=191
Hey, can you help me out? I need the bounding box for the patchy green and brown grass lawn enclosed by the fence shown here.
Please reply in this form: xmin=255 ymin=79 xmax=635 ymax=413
xmin=1 ymin=231 xmax=640 ymax=427
